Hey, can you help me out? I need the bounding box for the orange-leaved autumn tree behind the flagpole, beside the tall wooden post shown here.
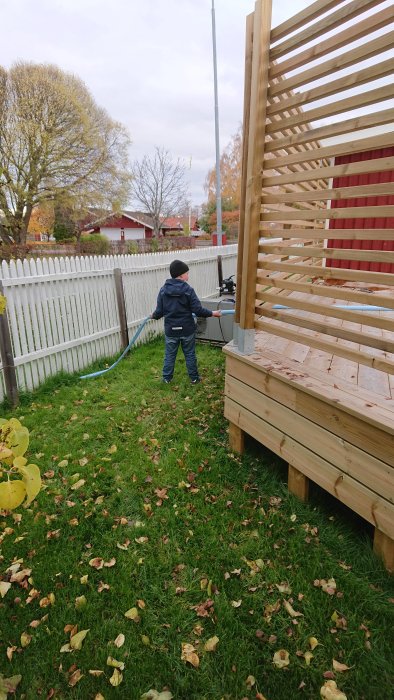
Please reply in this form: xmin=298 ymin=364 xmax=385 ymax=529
xmin=204 ymin=125 xmax=242 ymax=211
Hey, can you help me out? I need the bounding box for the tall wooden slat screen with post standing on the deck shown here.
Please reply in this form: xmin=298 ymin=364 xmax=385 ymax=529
xmin=237 ymin=0 xmax=394 ymax=373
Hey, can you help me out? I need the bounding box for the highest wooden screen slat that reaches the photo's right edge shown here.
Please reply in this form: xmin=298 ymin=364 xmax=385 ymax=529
xmin=269 ymin=7 xmax=393 ymax=81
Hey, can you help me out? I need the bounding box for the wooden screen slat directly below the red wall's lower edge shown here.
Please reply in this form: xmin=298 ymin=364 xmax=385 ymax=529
xmin=257 ymin=259 xmax=394 ymax=287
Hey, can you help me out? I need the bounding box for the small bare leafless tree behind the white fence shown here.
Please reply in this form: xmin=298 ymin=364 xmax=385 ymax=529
xmin=131 ymin=146 xmax=188 ymax=238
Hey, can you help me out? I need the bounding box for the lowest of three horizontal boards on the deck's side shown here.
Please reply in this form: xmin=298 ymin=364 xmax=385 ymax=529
xmin=224 ymin=397 xmax=394 ymax=539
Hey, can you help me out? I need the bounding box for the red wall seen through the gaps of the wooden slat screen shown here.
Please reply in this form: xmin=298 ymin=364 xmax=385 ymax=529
xmin=326 ymin=146 xmax=394 ymax=272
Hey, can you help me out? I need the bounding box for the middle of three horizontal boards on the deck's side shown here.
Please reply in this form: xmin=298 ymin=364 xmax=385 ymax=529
xmin=225 ymin=376 xmax=394 ymax=500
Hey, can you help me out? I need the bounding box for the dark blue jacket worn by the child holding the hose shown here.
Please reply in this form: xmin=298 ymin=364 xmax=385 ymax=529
xmin=152 ymin=278 xmax=212 ymax=338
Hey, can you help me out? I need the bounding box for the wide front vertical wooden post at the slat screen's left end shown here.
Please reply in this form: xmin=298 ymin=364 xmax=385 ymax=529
xmin=240 ymin=0 xmax=272 ymax=329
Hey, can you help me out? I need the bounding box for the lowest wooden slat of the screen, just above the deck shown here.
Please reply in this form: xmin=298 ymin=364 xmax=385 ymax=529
xmin=255 ymin=320 xmax=394 ymax=374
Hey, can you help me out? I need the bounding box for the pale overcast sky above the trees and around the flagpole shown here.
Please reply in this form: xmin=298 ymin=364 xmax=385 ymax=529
xmin=0 ymin=0 xmax=308 ymax=204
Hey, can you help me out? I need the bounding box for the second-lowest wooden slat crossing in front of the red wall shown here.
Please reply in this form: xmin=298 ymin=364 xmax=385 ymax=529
xmin=260 ymin=230 xmax=394 ymax=241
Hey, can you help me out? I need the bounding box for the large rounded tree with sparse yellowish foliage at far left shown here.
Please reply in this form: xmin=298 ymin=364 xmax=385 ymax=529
xmin=0 ymin=62 xmax=130 ymax=243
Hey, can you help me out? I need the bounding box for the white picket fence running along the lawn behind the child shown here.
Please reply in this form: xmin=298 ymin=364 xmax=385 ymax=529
xmin=0 ymin=245 xmax=237 ymax=402
